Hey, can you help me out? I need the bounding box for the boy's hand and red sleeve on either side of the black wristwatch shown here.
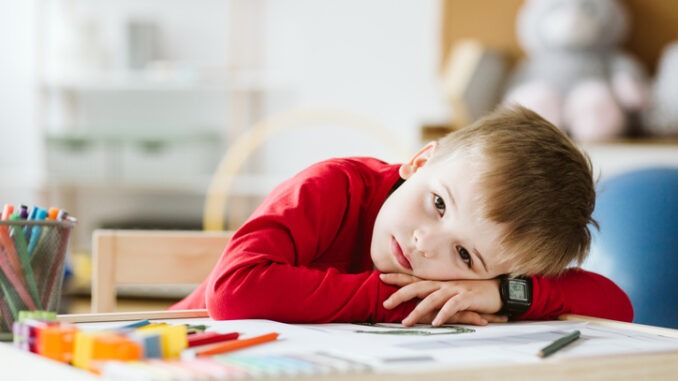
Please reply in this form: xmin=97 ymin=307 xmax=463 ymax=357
xmin=382 ymin=268 xmax=633 ymax=325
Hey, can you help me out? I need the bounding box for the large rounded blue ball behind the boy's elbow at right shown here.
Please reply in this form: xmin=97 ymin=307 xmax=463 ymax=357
xmin=584 ymin=168 xmax=678 ymax=328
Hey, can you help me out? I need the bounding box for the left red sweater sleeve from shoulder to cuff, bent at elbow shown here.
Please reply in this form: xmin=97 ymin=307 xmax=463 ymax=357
xmin=205 ymin=160 xmax=413 ymax=323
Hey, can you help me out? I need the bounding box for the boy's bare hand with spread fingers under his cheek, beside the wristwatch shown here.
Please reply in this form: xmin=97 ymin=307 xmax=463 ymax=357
xmin=380 ymin=273 xmax=507 ymax=326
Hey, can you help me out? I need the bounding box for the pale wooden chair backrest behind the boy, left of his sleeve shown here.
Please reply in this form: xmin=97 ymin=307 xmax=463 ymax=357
xmin=92 ymin=230 xmax=233 ymax=312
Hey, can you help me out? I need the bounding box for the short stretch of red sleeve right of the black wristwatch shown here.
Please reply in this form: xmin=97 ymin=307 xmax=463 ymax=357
xmin=520 ymin=268 xmax=633 ymax=322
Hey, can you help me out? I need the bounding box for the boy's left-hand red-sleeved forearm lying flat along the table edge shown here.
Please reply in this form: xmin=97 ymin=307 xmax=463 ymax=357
xmin=206 ymin=263 xmax=413 ymax=323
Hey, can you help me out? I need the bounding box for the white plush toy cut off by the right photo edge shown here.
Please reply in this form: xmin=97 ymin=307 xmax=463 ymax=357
xmin=643 ymin=40 xmax=678 ymax=137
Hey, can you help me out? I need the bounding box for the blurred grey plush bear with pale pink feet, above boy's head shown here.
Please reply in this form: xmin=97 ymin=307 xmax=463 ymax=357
xmin=503 ymin=0 xmax=649 ymax=142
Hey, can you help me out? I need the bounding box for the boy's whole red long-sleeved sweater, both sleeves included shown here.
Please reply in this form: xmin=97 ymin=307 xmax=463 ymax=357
xmin=171 ymin=158 xmax=633 ymax=323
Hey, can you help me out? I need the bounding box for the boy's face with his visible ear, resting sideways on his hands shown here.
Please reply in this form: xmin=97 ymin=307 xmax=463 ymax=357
xmin=371 ymin=143 xmax=508 ymax=280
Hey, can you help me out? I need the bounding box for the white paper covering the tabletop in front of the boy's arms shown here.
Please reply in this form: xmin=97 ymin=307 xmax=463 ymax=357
xmin=75 ymin=319 xmax=678 ymax=372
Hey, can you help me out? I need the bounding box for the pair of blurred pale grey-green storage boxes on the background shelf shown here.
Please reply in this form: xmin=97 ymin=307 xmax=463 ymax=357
xmin=46 ymin=129 xmax=221 ymax=194
